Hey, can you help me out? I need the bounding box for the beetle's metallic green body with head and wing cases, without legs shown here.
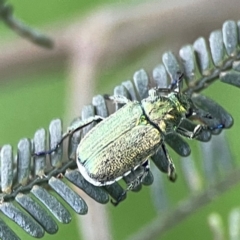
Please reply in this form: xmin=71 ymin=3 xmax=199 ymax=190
xmin=77 ymin=90 xmax=189 ymax=186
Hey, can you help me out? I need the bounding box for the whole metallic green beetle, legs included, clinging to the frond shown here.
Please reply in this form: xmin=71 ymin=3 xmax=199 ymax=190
xmin=35 ymin=75 xmax=224 ymax=205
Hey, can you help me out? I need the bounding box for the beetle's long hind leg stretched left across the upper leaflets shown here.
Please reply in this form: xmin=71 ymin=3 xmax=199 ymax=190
xmin=32 ymin=115 xmax=104 ymax=156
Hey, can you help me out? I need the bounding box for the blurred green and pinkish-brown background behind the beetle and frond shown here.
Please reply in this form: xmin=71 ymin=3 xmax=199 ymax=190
xmin=0 ymin=0 xmax=240 ymax=240
